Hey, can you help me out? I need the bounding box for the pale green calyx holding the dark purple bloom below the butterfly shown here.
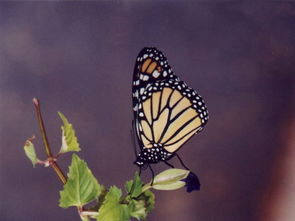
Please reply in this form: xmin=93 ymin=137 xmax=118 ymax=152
xmin=143 ymin=168 xmax=189 ymax=190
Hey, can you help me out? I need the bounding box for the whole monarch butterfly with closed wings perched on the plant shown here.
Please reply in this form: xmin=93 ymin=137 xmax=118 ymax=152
xmin=132 ymin=48 xmax=208 ymax=191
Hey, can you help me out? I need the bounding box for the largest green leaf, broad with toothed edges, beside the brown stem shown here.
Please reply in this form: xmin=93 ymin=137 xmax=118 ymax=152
xmin=59 ymin=154 xmax=101 ymax=208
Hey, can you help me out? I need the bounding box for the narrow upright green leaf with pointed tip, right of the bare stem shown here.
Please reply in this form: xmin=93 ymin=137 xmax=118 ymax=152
xmin=58 ymin=112 xmax=81 ymax=153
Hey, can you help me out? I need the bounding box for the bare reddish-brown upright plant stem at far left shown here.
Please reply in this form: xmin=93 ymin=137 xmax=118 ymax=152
xmin=33 ymin=98 xmax=67 ymax=184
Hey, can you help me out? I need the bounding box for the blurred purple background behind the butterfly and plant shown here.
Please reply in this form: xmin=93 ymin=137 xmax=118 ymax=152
xmin=0 ymin=1 xmax=295 ymax=221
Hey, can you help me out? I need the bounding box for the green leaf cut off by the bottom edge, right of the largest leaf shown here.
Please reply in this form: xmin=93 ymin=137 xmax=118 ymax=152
xmin=97 ymin=186 xmax=130 ymax=221
